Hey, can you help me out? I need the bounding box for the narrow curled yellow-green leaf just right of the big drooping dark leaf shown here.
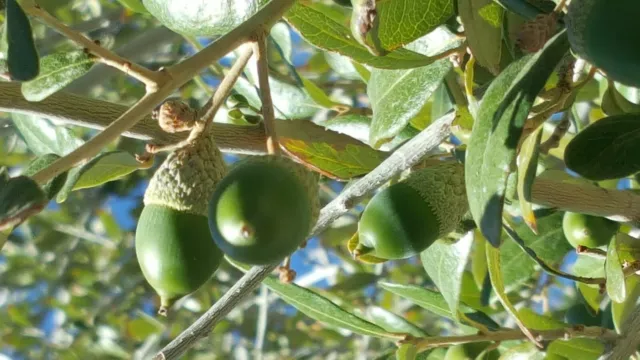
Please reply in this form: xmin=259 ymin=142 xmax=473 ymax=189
xmin=518 ymin=126 xmax=543 ymax=234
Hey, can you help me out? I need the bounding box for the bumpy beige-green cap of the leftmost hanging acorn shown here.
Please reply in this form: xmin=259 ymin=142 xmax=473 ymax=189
xmin=144 ymin=131 xmax=227 ymax=216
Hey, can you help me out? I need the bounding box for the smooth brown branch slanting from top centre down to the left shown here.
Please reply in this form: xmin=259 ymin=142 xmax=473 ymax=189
xmin=22 ymin=0 xmax=295 ymax=183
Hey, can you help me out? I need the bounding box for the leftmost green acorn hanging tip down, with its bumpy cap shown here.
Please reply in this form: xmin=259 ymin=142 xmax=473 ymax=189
xmin=135 ymin=132 xmax=227 ymax=315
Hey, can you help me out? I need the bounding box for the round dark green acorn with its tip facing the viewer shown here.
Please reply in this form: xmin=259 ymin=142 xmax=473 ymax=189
xmin=209 ymin=155 xmax=320 ymax=265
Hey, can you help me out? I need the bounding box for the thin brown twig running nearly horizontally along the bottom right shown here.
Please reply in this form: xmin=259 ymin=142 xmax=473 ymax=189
xmin=405 ymin=326 xmax=620 ymax=351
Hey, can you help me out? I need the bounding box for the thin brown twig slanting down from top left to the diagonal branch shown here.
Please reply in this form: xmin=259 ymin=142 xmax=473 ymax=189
xmin=24 ymin=2 xmax=168 ymax=91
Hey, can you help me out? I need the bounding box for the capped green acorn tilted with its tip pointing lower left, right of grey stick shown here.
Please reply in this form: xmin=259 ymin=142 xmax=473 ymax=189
xmin=353 ymin=162 xmax=469 ymax=260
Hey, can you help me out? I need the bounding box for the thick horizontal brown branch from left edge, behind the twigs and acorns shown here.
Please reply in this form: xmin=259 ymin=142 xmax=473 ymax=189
xmin=0 ymin=82 xmax=376 ymax=155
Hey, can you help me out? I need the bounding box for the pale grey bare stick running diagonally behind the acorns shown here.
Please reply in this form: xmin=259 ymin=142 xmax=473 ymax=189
xmin=154 ymin=113 xmax=455 ymax=360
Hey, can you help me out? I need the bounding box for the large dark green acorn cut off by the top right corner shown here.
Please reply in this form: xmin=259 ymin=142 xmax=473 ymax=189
xmin=565 ymin=0 xmax=640 ymax=87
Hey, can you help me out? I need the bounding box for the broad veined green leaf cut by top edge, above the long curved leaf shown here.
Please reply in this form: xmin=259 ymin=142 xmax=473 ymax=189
xmin=376 ymin=0 xmax=454 ymax=51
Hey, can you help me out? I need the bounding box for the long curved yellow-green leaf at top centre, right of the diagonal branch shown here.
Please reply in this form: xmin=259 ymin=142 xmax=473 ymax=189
xmin=285 ymin=1 xmax=435 ymax=69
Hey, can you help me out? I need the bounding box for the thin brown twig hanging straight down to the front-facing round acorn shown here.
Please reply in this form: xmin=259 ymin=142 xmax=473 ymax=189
xmin=254 ymin=33 xmax=280 ymax=155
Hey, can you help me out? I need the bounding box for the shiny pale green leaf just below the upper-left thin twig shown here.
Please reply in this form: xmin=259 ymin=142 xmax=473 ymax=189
xmin=22 ymin=50 xmax=95 ymax=101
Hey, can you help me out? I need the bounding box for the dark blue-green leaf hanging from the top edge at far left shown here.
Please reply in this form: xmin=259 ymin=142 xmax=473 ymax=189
xmin=6 ymin=0 xmax=40 ymax=81
